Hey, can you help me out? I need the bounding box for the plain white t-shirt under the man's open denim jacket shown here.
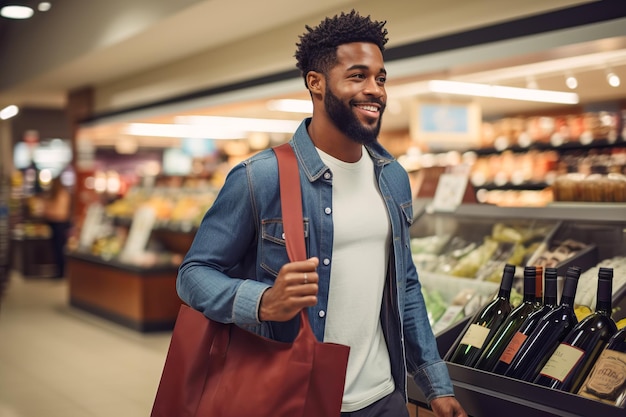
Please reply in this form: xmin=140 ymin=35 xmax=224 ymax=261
xmin=318 ymin=148 xmax=394 ymax=412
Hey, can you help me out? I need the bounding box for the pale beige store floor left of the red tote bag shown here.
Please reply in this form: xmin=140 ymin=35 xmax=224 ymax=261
xmin=0 ymin=274 xmax=171 ymax=417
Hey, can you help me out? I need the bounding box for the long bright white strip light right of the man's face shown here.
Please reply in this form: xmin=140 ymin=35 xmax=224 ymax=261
xmin=428 ymin=80 xmax=579 ymax=104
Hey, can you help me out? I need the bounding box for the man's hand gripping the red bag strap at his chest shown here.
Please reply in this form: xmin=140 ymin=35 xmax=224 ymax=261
xmin=259 ymin=257 xmax=319 ymax=321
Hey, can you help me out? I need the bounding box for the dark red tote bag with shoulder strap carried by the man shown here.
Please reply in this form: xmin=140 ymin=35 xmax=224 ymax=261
xmin=151 ymin=144 xmax=350 ymax=417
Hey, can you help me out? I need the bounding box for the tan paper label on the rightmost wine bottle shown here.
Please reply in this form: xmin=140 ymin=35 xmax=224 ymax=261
xmin=578 ymin=349 xmax=626 ymax=405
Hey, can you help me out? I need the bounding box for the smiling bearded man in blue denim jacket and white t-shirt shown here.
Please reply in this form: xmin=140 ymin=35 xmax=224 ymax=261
xmin=177 ymin=11 xmax=466 ymax=417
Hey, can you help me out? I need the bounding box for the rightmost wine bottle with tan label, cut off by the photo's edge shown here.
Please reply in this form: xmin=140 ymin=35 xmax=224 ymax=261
xmin=578 ymin=327 xmax=626 ymax=407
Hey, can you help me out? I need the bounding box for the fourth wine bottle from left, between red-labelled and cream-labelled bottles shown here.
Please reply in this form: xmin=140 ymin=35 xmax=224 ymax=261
xmin=494 ymin=266 xmax=582 ymax=382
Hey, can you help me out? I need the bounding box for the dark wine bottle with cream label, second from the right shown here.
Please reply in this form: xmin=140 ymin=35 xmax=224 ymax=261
xmin=534 ymin=267 xmax=617 ymax=392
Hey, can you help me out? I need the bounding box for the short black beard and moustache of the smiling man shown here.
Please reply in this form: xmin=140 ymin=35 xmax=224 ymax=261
xmin=324 ymin=86 xmax=385 ymax=145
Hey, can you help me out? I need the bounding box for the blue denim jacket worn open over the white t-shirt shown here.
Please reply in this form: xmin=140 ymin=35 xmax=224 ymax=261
xmin=177 ymin=119 xmax=453 ymax=401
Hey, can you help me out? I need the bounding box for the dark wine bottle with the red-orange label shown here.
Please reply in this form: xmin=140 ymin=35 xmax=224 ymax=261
xmin=491 ymin=267 xmax=560 ymax=375
